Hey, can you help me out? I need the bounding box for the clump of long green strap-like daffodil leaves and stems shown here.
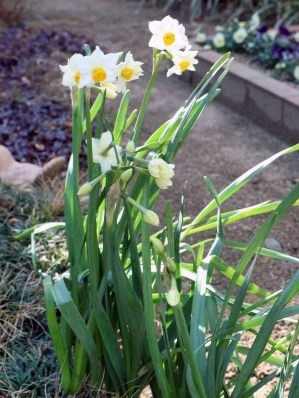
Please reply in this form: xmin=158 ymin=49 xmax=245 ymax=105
xmin=23 ymin=41 xmax=299 ymax=398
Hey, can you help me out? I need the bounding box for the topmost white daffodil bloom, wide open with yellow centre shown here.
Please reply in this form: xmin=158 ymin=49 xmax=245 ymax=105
xmin=148 ymin=15 xmax=188 ymax=53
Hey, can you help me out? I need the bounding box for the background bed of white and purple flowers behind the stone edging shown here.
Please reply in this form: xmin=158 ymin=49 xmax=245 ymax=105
xmin=196 ymin=14 xmax=299 ymax=85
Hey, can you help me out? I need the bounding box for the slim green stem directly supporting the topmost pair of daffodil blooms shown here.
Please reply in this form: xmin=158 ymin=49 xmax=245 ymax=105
xmin=132 ymin=53 xmax=164 ymax=144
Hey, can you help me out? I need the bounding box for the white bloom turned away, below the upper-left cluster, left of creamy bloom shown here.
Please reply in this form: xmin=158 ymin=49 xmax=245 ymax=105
xmin=92 ymin=131 xmax=121 ymax=173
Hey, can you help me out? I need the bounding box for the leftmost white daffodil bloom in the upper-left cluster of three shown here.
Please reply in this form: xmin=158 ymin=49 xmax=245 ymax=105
xmin=59 ymin=54 xmax=88 ymax=88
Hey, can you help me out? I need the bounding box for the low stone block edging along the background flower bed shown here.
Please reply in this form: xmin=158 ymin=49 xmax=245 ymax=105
xmin=185 ymin=44 xmax=299 ymax=143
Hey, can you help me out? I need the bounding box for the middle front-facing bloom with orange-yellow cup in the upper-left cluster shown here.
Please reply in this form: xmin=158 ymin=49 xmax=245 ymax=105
xmin=85 ymin=46 xmax=122 ymax=86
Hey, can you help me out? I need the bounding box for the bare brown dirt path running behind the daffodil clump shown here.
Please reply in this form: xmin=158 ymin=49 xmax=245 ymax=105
xmin=12 ymin=0 xmax=299 ymax=397
